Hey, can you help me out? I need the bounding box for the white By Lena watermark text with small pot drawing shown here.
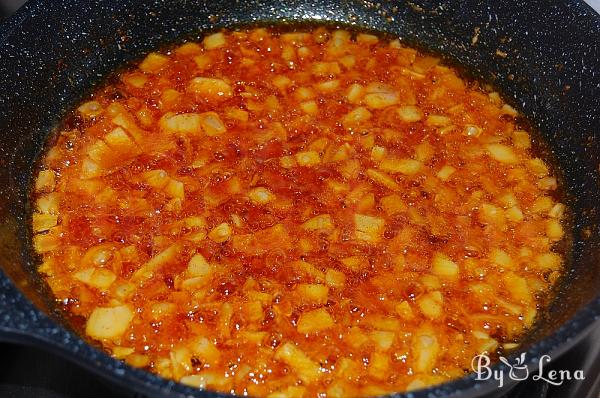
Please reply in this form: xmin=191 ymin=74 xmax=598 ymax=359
xmin=471 ymin=353 xmax=585 ymax=388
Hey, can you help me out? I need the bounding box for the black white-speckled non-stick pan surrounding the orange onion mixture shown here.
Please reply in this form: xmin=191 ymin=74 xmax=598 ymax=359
xmin=0 ymin=0 xmax=600 ymax=397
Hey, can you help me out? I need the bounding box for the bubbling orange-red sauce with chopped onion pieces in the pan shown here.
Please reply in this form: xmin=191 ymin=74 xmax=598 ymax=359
xmin=32 ymin=28 xmax=565 ymax=397
